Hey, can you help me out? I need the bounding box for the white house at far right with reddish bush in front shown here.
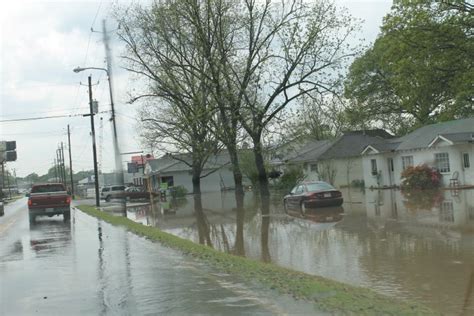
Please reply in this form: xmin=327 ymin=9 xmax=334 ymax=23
xmin=361 ymin=118 xmax=474 ymax=187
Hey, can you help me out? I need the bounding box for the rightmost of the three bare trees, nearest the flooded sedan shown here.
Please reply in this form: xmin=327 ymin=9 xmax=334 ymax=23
xmin=223 ymin=0 xmax=356 ymax=196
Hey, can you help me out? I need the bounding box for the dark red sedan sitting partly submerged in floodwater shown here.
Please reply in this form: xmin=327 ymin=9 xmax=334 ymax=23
xmin=283 ymin=181 xmax=343 ymax=214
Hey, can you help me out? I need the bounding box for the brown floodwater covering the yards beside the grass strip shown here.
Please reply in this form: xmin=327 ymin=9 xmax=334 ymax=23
xmin=128 ymin=190 xmax=474 ymax=315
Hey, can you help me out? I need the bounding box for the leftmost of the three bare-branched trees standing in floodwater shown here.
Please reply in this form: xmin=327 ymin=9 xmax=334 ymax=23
xmin=119 ymin=2 xmax=217 ymax=193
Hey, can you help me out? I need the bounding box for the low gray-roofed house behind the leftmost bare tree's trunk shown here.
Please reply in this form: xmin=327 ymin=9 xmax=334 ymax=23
xmin=145 ymin=152 xmax=241 ymax=193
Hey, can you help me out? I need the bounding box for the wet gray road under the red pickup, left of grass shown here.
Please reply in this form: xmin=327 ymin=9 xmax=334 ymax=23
xmin=0 ymin=199 xmax=316 ymax=315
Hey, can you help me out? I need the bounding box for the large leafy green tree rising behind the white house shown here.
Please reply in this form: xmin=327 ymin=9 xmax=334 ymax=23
xmin=345 ymin=0 xmax=474 ymax=133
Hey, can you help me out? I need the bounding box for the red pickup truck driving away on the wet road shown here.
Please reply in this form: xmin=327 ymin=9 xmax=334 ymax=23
xmin=28 ymin=183 xmax=71 ymax=223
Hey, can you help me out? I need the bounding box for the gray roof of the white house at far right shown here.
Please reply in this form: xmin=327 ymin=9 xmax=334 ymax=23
xmin=397 ymin=117 xmax=474 ymax=150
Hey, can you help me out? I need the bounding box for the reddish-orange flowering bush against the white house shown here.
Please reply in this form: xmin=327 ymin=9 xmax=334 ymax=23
xmin=402 ymin=164 xmax=441 ymax=190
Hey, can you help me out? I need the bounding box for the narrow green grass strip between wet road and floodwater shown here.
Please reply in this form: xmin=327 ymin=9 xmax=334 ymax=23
xmin=78 ymin=205 xmax=437 ymax=315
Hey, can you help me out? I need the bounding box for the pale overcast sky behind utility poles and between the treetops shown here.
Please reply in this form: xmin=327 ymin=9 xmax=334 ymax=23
xmin=0 ymin=0 xmax=392 ymax=177
